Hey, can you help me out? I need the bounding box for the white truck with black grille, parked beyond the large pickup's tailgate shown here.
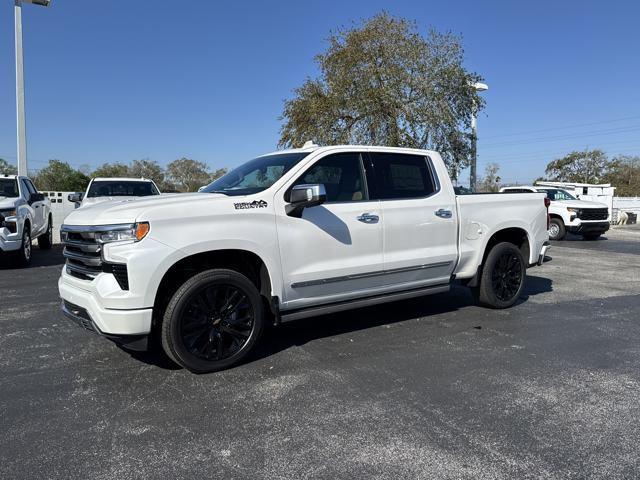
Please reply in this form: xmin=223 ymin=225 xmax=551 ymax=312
xmin=500 ymin=185 xmax=611 ymax=240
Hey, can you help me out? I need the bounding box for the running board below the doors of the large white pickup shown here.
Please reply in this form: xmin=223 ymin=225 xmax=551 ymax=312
xmin=280 ymin=283 xmax=451 ymax=323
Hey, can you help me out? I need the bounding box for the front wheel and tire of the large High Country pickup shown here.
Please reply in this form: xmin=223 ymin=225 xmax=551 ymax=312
xmin=160 ymin=269 xmax=265 ymax=373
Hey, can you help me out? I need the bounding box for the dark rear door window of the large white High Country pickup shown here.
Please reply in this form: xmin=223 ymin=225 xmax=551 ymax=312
xmin=371 ymin=152 xmax=436 ymax=200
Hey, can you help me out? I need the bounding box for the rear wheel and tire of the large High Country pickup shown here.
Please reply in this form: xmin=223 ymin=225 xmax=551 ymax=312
xmin=477 ymin=242 xmax=527 ymax=308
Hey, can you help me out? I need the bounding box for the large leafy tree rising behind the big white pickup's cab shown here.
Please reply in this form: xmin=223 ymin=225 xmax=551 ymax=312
xmin=279 ymin=12 xmax=484 ymax=177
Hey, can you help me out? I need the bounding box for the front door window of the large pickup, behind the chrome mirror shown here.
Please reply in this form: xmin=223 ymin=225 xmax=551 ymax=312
xmin=294 ymin=153 xmax=368 ymax=202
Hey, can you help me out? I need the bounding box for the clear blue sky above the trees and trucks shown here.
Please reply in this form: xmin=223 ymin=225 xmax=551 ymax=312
xmin=0 ymin=0 xmax=640 ymax=182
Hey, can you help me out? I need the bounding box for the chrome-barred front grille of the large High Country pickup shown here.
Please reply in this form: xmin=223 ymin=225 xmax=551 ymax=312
xmin=61 ymin=225 xmax=129 ymax=290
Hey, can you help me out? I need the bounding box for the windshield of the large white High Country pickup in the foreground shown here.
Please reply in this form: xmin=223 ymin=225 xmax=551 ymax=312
xmin=201 ymin=152 xmax=309 ymax=195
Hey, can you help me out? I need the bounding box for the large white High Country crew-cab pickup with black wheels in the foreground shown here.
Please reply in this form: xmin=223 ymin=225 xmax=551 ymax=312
xmin=58 ymin=146 xmax=548 ymax=372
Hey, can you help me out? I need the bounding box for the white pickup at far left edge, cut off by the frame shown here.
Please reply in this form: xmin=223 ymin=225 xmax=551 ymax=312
xmin=0 ymin=175 xmax=53 ymax=266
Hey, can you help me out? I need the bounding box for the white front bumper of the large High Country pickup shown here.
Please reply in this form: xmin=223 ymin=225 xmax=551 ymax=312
xmin=58 ymin=274 xmax=153 ymax=337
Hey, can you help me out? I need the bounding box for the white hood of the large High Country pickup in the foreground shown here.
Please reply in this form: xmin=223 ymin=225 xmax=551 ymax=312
xmin=64 ymin=193 xmax=230 ymax=225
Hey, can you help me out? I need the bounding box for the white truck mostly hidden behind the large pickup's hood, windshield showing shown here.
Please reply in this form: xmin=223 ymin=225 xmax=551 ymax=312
xmin=68 ymin=178 xmax=160 ymax=207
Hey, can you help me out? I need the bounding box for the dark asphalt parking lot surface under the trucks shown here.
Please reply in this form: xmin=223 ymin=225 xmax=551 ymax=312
xmin=0 ymin=228 xmax=640 ymax=479
